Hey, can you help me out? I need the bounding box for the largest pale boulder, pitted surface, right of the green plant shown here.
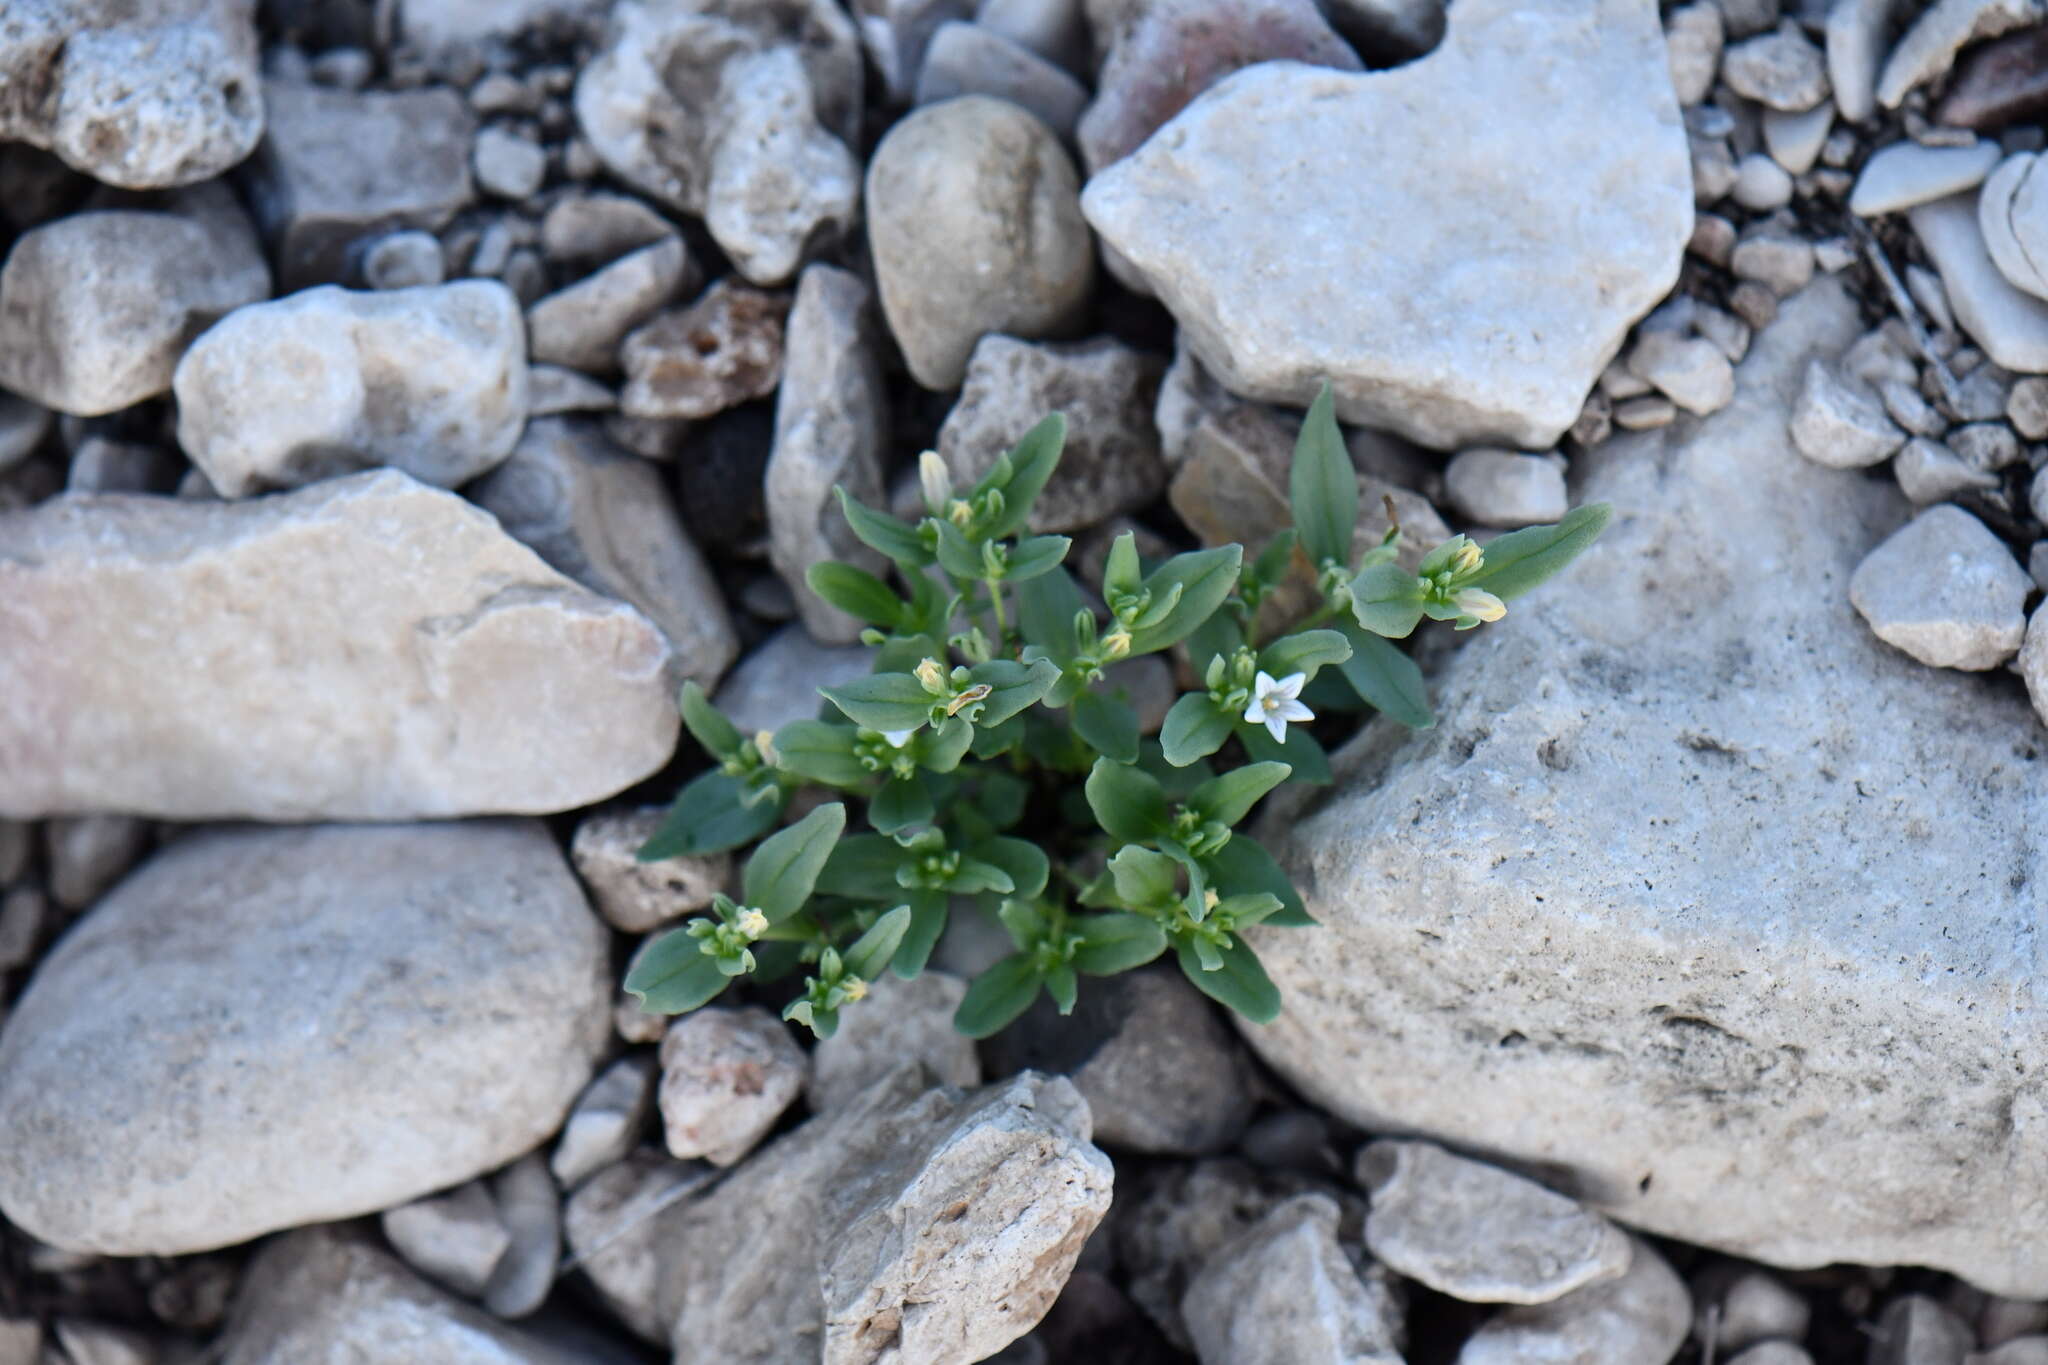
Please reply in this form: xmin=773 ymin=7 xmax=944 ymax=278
xmin=1247 ymin=282 xmax=2048 ymax=1297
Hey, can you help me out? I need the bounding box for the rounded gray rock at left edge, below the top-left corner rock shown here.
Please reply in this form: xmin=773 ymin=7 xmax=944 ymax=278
xmin=0 ymin=186 xmax=270 ymax=417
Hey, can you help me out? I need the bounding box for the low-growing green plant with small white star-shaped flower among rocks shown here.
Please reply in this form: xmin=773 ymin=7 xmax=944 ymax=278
xmin=625 ymin=385 xmax=1608 ymax=1038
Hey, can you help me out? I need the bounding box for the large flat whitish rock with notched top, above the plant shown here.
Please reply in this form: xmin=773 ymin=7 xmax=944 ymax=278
xmin=1081 ymin=0 xmax=1692 ymax=450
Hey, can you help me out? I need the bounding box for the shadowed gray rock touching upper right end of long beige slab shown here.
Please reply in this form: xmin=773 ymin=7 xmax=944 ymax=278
xmin=469 ymin=417 xmax=739 ymax=688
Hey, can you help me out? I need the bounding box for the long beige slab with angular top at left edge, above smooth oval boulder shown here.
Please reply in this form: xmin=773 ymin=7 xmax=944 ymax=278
xmin=0 ymin=471 xmax=678 ymax=821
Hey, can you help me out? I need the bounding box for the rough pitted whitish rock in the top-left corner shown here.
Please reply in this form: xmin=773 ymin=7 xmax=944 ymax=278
xmin=0 ymin=0 xmax=264 ymax=190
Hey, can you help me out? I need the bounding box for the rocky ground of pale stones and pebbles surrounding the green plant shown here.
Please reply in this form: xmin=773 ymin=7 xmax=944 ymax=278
xmin=0 ymin=0 xmax=2048 ymax=1365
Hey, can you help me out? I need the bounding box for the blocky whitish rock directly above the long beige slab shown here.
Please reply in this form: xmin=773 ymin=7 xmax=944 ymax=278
xmin=172 ymin=280 xmax=526 ymax=497
